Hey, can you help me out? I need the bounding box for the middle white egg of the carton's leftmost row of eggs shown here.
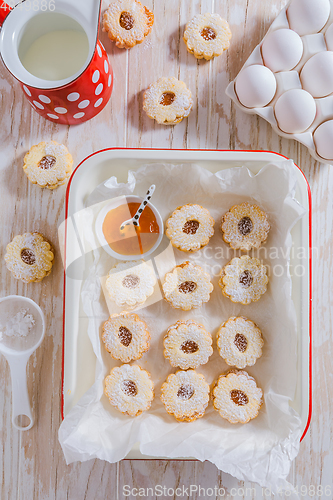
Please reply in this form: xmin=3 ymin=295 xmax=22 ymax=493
xmin=261 ymin=29 xmax=303 ymax=72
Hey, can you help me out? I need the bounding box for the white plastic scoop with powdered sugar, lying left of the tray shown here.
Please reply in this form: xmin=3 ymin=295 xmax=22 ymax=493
xmin=0 ymin=295 xmax=45 ymax=431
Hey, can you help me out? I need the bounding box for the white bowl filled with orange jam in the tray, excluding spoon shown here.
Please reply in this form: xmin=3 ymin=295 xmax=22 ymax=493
xmin=95 ymin=195 xmax=163 ymax=260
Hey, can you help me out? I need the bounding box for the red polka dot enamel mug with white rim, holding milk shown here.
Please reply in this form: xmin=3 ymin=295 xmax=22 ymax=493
xmin=0 ymin=0 xmax=113 ymax=125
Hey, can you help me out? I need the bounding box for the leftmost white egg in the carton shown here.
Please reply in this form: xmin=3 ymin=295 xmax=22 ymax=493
xmin=235 ymin=64 xmax=276 ymax=108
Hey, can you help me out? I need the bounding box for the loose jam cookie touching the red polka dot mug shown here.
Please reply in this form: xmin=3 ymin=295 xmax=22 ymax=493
xmin=103 ymin=0 xmax=154 ymax=49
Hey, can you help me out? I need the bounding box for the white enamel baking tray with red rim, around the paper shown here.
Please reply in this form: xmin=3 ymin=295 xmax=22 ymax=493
xmin=61 ymin=148 xmax=311 ymax=458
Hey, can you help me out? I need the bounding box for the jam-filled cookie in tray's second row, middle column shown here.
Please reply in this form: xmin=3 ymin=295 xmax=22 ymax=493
xmin=162 ymin=261 xmax=213 ymax=311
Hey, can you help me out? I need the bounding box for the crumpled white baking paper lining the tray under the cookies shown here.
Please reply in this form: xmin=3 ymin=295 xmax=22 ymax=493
xmin=59 ymin=160 xmax=305 ymax=491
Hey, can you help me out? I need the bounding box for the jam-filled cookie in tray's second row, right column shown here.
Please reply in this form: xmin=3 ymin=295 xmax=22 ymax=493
xmin=219 ymin=255 xmax=268 ymax=305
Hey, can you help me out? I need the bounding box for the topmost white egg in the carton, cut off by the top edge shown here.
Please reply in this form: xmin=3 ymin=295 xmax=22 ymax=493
xmin=287 ymin=0 xmax=330 ymax=36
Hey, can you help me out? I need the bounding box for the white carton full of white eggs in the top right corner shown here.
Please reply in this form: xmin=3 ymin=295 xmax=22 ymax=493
xmin=226 ymin=0 xmax=333 ymax=163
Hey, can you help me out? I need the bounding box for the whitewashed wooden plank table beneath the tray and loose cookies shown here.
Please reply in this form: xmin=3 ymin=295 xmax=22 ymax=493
xmin=0 ymin=0 xmax=333 ymax=500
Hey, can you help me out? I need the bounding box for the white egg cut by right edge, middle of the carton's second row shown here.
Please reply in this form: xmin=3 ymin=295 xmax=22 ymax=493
xmin=300 ymin=51 xmax=333 ymax=97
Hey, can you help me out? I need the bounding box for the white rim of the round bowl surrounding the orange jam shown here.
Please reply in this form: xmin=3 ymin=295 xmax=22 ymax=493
xmin=95 ymin=195 xmax=164 ymax=260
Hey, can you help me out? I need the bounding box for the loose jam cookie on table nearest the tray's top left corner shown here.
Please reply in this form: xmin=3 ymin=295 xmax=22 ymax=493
xmin=23 ymin=141 xmax=73 ymax=189
